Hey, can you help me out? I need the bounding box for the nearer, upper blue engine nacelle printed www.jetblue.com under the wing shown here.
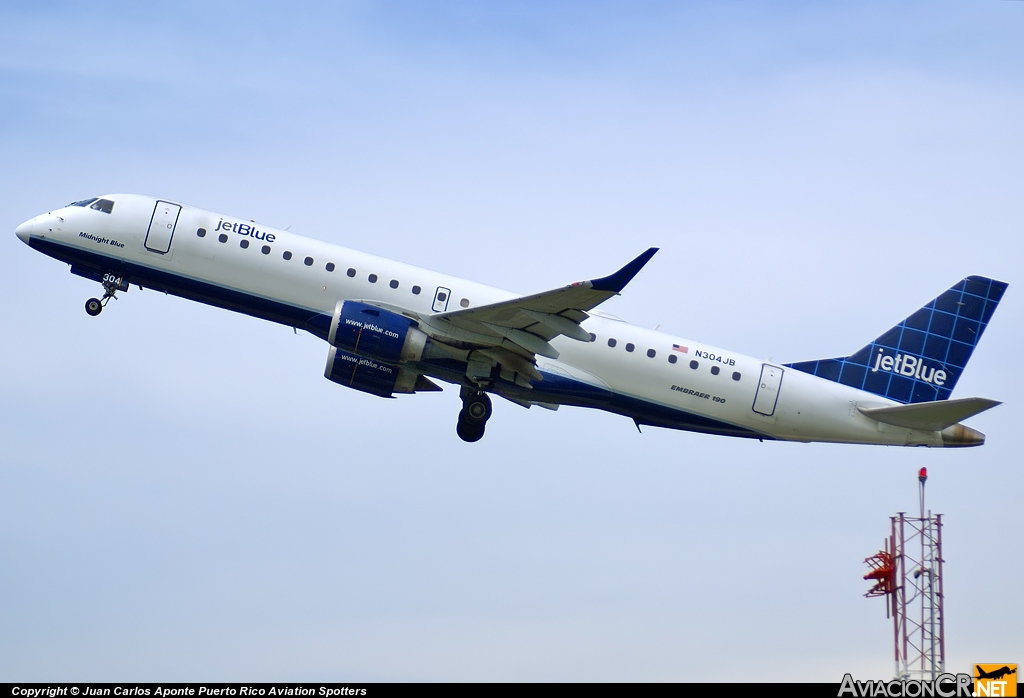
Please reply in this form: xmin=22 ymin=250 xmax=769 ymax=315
xmin=328 ymin=301 xmax=428 ymax=362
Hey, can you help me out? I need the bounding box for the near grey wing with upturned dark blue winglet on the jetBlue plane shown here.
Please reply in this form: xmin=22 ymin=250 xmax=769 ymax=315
xmin=422 ymin=248 xmax=657 ymax=359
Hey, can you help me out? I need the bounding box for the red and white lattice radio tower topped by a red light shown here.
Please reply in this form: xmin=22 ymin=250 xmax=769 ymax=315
xmin=864 ymin=468 xmax=946 ymax=680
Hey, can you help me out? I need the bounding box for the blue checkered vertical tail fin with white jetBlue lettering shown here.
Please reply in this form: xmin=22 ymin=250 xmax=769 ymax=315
xmin=785 ymin=276 xmax=1008 ymax=403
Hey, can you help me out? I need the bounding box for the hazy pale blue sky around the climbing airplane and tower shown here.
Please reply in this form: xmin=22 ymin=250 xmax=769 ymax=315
xmin=0 ymin=0 xmax=1024 ymax=682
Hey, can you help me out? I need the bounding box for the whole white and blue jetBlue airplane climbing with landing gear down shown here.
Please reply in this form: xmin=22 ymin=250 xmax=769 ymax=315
xmin=16 ymin=194 xmax=1007 ymax=447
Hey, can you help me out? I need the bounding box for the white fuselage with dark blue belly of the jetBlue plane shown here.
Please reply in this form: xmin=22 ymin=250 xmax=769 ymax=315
xmin=17 ymin=194 xmax=999 ymax=446
